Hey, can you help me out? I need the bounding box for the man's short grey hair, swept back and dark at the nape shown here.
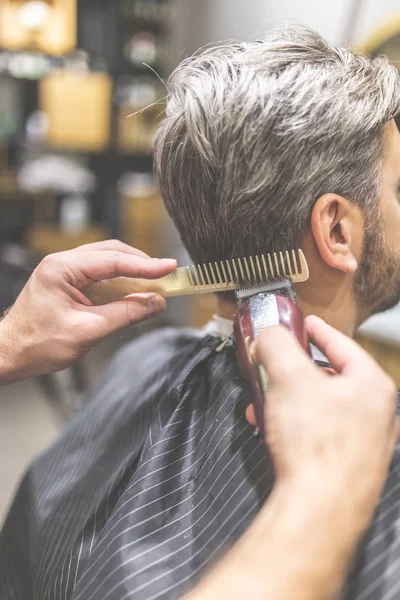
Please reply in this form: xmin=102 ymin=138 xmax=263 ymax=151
xmin=155 ymin=26 xmax=400 ymax=261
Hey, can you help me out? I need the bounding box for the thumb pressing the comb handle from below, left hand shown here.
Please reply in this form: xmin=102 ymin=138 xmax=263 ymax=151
xmin=86 ymin=293 xmax=166 ymax=338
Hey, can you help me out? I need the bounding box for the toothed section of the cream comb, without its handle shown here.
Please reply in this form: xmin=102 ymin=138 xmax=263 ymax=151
xmin=185 ymin=250 xmax=308 ymax=287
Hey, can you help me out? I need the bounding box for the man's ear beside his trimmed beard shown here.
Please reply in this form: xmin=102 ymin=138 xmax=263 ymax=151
xmin=311 ymin=194 xmax=364 ymax=274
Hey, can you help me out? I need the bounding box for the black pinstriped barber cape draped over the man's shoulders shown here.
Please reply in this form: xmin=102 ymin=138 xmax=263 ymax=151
xmin=0 ymin=329 xmax=400 ymax=600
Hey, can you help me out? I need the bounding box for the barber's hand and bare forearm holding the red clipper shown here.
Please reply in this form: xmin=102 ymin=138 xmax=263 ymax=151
xmin=187 ymin=317 xmax=399 ymax=600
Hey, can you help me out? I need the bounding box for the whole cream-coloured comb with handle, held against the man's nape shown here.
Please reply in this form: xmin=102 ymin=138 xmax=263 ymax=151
xmin=82 ymin=250 xmax=309 ymax=305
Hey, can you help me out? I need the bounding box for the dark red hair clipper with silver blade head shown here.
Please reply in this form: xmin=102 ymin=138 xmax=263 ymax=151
xmin=234 ymin=280 xmax=311 ymax=440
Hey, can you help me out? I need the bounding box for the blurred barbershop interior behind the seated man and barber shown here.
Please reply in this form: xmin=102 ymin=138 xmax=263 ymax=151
xmin=0 ymin=0 xmax=400 ymax=522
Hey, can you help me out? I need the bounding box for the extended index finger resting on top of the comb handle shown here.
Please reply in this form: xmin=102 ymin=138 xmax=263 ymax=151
xmin=65 ymin=250 xmax=176 ymax=288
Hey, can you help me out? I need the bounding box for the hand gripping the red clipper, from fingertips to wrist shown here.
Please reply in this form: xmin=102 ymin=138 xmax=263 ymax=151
xmin=254 ymin=317 xmax=399 ymax=519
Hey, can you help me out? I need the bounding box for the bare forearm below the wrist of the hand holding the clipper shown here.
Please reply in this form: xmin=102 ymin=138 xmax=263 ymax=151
xmin=187 ymin=484 xmax=370 ymax=600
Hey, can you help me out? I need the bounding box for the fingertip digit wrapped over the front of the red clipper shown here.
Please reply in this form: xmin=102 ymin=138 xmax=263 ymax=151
xmin=255 ymin=326 xmax=318 ymax=386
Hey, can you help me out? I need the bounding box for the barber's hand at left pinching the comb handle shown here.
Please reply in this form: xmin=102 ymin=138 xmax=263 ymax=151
xmin=0 ymin=240 xmax=176 ymax=383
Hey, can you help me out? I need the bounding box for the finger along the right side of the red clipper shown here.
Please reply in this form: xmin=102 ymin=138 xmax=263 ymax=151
xmin=305 ymin=316 xmax=376 ymax=374
